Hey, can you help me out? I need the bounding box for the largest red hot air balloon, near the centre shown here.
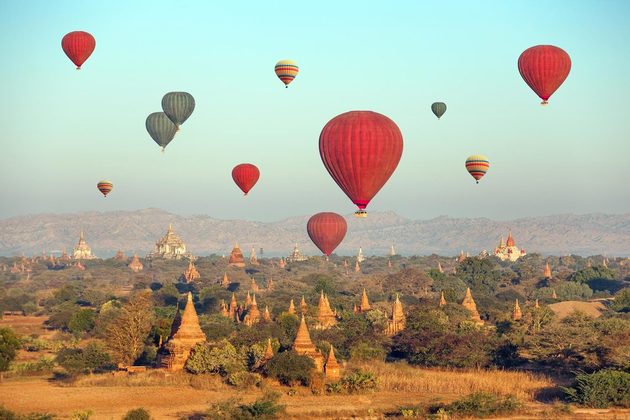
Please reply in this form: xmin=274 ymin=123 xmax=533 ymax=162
xmin=319 ymin=111 xmax=403 ymax=217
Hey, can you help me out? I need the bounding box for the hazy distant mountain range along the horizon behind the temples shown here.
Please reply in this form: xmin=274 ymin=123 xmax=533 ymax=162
xmin=0 ymin=209 xmax=630 ymax=257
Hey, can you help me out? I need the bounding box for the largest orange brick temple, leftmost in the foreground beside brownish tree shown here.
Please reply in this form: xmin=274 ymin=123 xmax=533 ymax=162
xmin=157 ymin=292 xmax=206 ymax=371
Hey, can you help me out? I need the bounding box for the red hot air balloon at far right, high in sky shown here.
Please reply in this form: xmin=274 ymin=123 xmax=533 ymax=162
xmin=518 ymin=45 xmax=571 ymax=105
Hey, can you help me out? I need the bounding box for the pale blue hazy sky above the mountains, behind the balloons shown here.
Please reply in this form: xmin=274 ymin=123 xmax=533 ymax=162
xmin=0 ymin=0 xmax=630 ymax=221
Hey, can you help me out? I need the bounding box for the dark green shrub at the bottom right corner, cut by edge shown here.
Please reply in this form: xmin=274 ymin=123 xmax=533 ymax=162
xmin=564 ymin=369 xmax=630 ymax=408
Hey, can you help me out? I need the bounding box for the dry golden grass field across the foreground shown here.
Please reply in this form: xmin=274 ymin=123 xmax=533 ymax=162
xmin=0 ymin=363 xmax=630 ymax=419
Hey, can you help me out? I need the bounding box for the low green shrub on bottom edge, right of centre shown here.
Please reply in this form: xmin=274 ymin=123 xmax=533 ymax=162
xmin=431 ymin=392 xmax=521 ymax=417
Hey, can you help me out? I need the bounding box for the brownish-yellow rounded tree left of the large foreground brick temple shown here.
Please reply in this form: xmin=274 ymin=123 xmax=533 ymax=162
xmin=106 ymin=292 xmax=154 ymax=365
